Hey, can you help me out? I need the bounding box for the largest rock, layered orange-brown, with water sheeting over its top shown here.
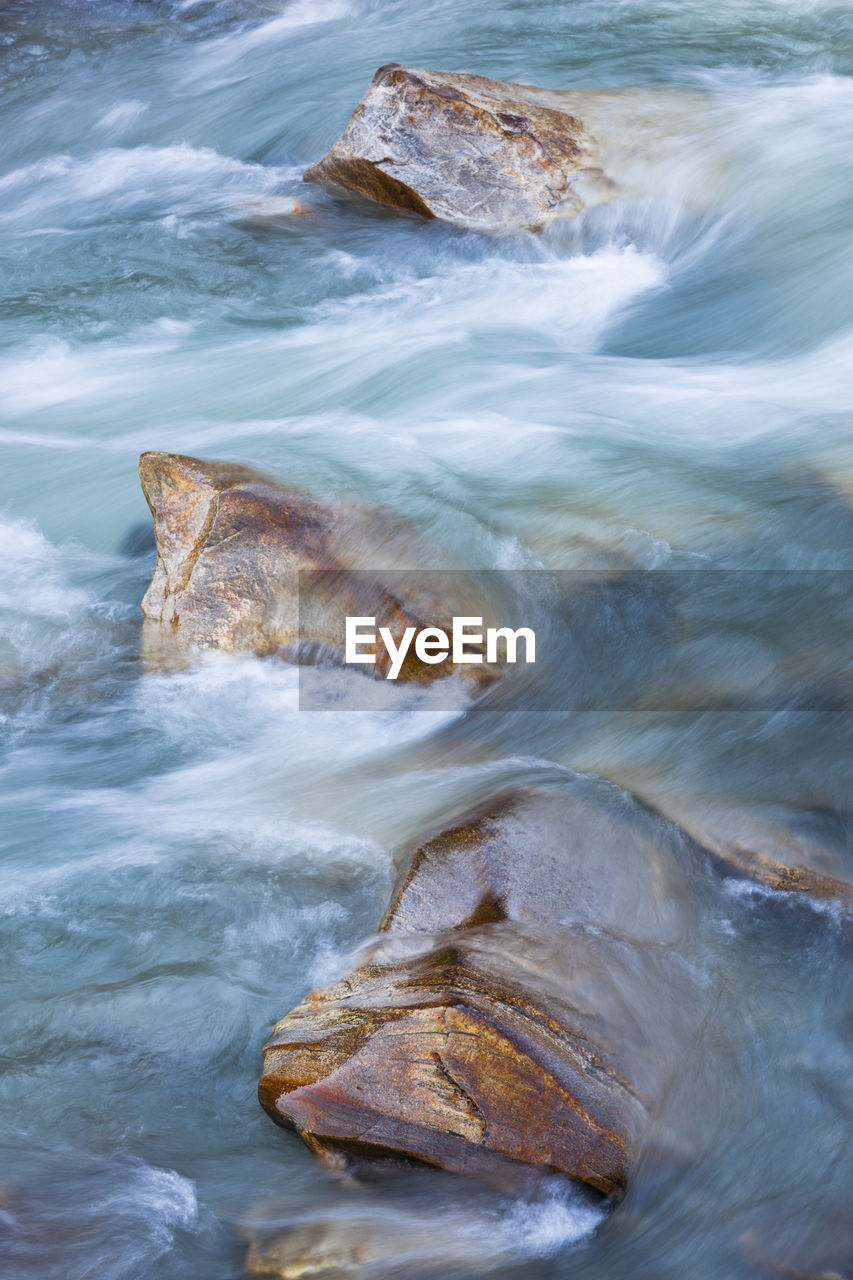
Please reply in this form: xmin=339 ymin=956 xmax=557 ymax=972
xmin=260 ymin=782 xmax=697 ymax=1197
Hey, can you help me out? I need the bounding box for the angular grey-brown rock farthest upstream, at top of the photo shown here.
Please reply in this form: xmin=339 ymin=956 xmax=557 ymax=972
xmin=304 ymin=63 xmax=707 ymax=230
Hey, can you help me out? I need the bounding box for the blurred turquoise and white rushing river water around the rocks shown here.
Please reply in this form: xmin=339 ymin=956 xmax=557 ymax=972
xmin=0 ymin=0 xmax=853 ymax=1280
